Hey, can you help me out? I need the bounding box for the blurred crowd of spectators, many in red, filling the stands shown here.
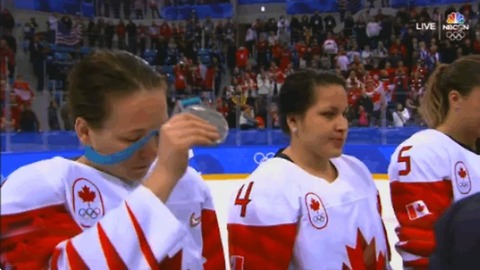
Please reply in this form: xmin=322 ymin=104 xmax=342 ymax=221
xmin=0 ymin=1 xmax=480 ymax=133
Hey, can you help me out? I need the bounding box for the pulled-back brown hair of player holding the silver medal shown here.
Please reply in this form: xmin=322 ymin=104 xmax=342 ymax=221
xmin=67 ymin=50 xmax=166 ymax=129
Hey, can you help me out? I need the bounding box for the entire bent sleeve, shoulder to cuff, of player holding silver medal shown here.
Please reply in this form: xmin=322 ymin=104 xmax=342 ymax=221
xmin=0 ymin=166 xmax=187 ymax=269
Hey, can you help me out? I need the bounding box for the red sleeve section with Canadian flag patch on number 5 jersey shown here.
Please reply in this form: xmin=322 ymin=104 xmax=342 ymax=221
xmin=390 ymin=181 xmax=453 ymax=267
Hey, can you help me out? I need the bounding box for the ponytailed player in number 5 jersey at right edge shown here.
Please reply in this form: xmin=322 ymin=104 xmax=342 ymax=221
xmin=388 ymin=55 xmax=480 ymax=269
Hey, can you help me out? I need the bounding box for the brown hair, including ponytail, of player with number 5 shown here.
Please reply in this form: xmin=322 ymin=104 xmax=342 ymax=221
xmin=420 ymin=55 xmax=480 ymax=128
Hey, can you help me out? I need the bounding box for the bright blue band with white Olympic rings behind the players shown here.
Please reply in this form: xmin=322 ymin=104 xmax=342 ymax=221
xmin=1 ymin=145 xmax=396 ymax=177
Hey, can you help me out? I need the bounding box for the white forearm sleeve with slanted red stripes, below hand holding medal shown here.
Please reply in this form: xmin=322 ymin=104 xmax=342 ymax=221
xmin=51 ymin=187 xmax=186 ymax=269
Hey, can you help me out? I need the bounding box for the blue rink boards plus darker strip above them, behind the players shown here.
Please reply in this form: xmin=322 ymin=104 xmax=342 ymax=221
xmin=0 ymin=127 xmax=421 ymax=176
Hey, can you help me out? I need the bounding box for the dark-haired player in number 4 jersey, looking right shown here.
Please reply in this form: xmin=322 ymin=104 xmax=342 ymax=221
xmin=227 ymin=71 xmax=389 ymax=270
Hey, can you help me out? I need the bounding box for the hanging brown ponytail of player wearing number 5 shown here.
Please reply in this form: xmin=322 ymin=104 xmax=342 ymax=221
xmin=420 ymin=64 xmax=449 ymax=128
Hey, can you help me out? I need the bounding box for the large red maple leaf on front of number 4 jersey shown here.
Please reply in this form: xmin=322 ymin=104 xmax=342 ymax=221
xmin=342 ymin=229 xmax=386 ymax=270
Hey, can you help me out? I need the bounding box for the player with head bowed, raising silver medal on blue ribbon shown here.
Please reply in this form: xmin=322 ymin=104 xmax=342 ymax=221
xmin=0 ymin=51 xmax=225 ymax=270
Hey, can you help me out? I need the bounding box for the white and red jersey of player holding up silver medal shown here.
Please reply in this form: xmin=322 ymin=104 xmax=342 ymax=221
xmin=0 ymin=157 xmax=225 ymax=270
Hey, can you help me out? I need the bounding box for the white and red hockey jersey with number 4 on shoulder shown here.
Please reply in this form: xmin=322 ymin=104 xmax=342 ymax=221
xmin=227 ymin=155 xmax=389 ymax=270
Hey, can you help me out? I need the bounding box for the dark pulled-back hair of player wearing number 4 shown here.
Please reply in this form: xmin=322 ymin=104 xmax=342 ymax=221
xmin=278 ymin=70 xmax=346 ymax=134
